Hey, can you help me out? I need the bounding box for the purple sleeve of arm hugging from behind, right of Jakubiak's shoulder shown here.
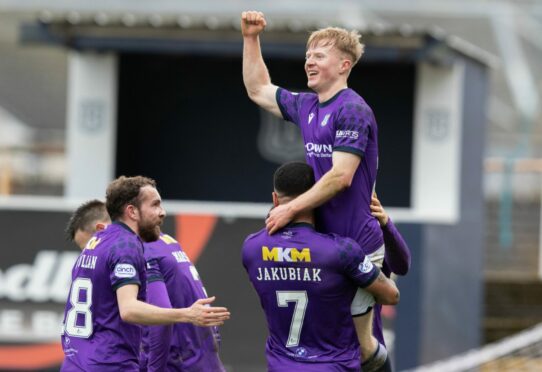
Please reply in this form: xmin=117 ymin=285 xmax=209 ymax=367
xmin=382 ymin=219 xmax=410 ymax=275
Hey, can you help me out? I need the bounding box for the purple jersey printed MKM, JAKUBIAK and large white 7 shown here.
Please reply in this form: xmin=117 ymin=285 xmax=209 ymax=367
xmin=242 ymin=223 xmax=379 ymax=371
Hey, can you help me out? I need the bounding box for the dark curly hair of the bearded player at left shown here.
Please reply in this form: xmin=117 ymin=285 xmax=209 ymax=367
xmin=105 ymin=176 xmax=156 ymax=221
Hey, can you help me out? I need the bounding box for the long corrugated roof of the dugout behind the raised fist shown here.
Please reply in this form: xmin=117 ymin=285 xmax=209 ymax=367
xmin=21 ymin=11 xmax=498 ymax=67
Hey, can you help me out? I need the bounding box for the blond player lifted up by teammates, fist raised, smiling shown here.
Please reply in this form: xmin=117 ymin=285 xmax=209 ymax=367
xmin=241 ymin=11 xmax=389 ymax=370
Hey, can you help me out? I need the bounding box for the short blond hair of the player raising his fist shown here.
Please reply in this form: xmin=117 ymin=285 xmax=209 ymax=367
xmin=307 ymin=27 xmax=365 ymax=66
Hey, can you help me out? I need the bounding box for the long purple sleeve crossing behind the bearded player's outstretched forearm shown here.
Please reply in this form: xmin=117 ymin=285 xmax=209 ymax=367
xmin=147 ymin=280 xmax=173 ymax=372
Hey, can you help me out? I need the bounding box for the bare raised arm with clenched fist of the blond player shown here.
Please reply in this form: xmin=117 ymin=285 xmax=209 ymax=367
xmin=241 ymin=11 xmax=282 ymax=118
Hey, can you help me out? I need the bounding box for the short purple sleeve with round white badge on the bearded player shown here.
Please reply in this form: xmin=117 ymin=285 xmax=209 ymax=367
xmin=109 ymin=237 xmax=146 ymax=290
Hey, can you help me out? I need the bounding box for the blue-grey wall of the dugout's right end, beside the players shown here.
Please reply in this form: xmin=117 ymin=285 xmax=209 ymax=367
xmin=396 ymin=58 xmax=487 ymax=369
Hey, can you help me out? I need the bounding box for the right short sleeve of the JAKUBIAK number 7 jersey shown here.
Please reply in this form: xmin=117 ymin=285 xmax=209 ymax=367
xmin=337 ymin=238 xmax=380 ymax=288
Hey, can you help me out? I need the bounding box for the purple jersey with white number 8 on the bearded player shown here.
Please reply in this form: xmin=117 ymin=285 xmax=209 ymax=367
xmin=61 ymin=222 xmax=147 ymax=371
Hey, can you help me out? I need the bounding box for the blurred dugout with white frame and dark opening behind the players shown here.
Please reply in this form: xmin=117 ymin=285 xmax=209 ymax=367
xmin=21 ymin=13 xmax=494 ymax=369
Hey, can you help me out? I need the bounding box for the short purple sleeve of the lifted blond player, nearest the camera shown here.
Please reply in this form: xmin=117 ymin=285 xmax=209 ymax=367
xmin=333 ymin=101 xmax=375 ymax=156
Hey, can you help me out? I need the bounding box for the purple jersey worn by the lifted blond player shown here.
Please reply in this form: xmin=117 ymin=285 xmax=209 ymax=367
xmin=276 ymin=88 xmax=384 ymax=254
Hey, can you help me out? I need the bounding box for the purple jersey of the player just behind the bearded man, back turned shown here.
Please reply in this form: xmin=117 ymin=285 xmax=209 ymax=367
xmin=141 ymin=234 xmax=225 ymax=372
